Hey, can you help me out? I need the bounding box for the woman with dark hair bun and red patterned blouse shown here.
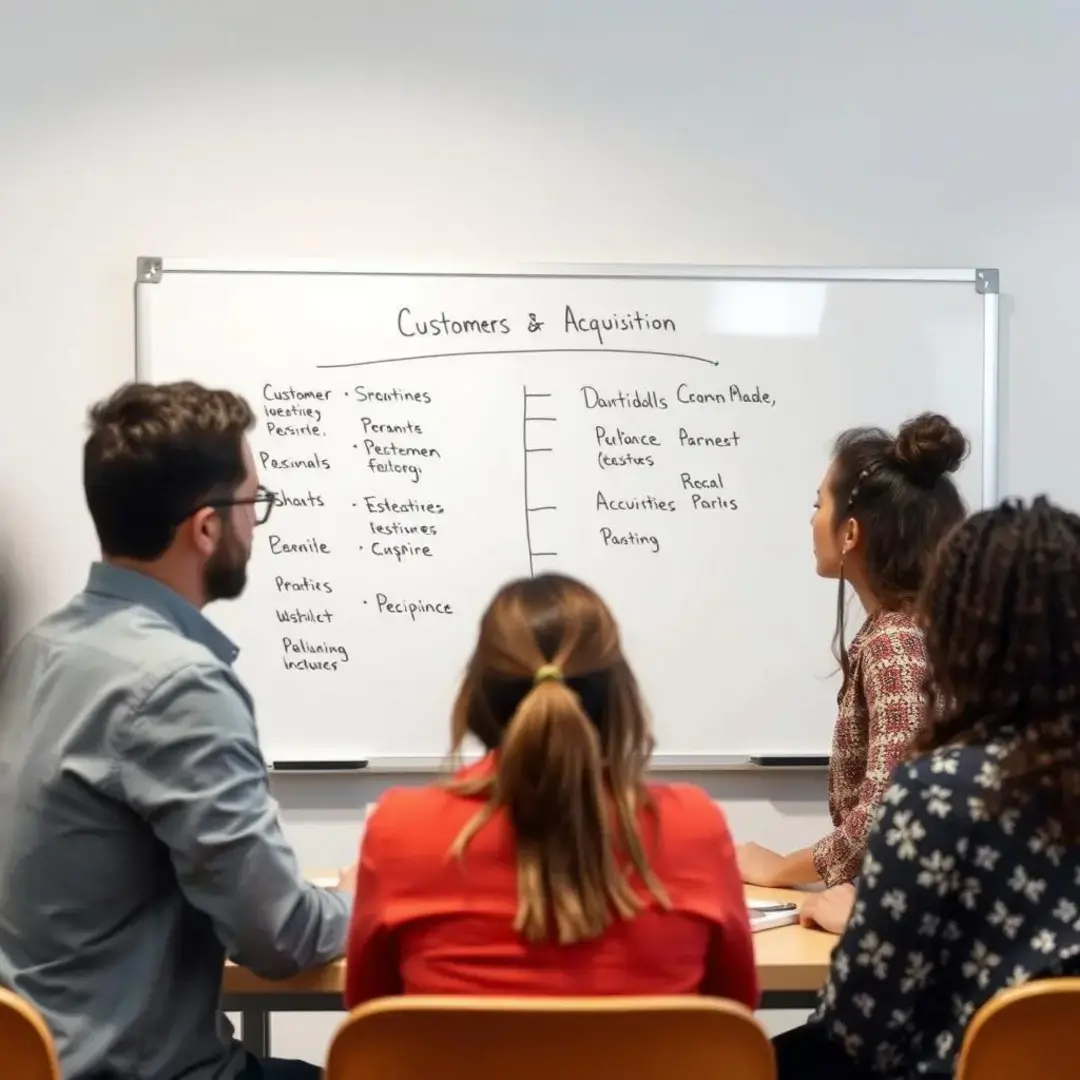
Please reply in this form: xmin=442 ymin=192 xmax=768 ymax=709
xmin=739 ymin=413 xmax=968 ymax=887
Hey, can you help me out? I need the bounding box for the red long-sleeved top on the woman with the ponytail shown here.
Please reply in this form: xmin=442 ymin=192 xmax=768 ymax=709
xmin=345 ymin=756 xmax=758 ymax=1009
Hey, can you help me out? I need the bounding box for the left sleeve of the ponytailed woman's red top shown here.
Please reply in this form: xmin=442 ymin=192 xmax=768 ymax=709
xmin=345 ymin=809 xmax=403 ymax=1009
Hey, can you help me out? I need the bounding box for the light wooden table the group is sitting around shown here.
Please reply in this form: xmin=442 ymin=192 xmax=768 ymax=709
xmin=221 ymin=887 xmax=838 ymax=1056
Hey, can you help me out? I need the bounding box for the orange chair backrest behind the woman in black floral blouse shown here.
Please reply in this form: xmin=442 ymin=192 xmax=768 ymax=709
xmin=956 ymin=978 xmax=1080 ymax=1080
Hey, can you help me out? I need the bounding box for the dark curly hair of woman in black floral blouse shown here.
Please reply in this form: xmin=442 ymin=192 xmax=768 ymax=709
xmin=910 ymin=496 xmax=1080 ymax=843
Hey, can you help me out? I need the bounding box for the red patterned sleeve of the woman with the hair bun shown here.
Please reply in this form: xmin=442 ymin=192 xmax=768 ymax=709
xmin=812 ymin=638 xmax=926 ymax=886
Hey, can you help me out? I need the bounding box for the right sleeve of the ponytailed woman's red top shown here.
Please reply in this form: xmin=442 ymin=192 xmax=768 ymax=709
xmin=701 ymin=806 xmax=760 ymax=1009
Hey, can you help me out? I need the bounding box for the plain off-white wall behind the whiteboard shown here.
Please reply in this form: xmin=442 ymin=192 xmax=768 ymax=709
xmin=0 ymin=0 xmax=1080 ymax=1057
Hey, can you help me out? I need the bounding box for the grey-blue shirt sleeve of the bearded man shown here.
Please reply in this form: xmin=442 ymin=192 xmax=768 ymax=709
xmin=114 ymin=664 xmax=350 ymax=978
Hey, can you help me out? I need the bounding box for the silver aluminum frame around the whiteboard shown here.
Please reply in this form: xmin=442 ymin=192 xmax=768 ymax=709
xmin=134 ymin=255 xmax=1001 ymax=777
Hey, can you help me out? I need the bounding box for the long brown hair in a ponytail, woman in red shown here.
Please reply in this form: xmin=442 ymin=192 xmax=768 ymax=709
xmin=450 ymin=575 xmax=667 ymax=945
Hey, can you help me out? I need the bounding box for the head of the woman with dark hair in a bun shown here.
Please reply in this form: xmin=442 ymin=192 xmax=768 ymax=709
xmin=811 ymin=413 xmax=968 ymax=669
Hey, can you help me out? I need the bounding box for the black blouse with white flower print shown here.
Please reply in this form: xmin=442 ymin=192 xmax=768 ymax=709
xmin=811 ymin=742 xmax=1080 ymax=1078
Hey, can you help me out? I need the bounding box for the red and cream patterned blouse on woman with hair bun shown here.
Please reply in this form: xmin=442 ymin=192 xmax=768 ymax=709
xmin=813 ymin=611 xmax=927 ymax=886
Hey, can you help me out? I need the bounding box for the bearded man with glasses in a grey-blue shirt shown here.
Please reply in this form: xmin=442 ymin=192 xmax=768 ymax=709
xmin=0 ymin=383 xmax=352 ymax=1080
